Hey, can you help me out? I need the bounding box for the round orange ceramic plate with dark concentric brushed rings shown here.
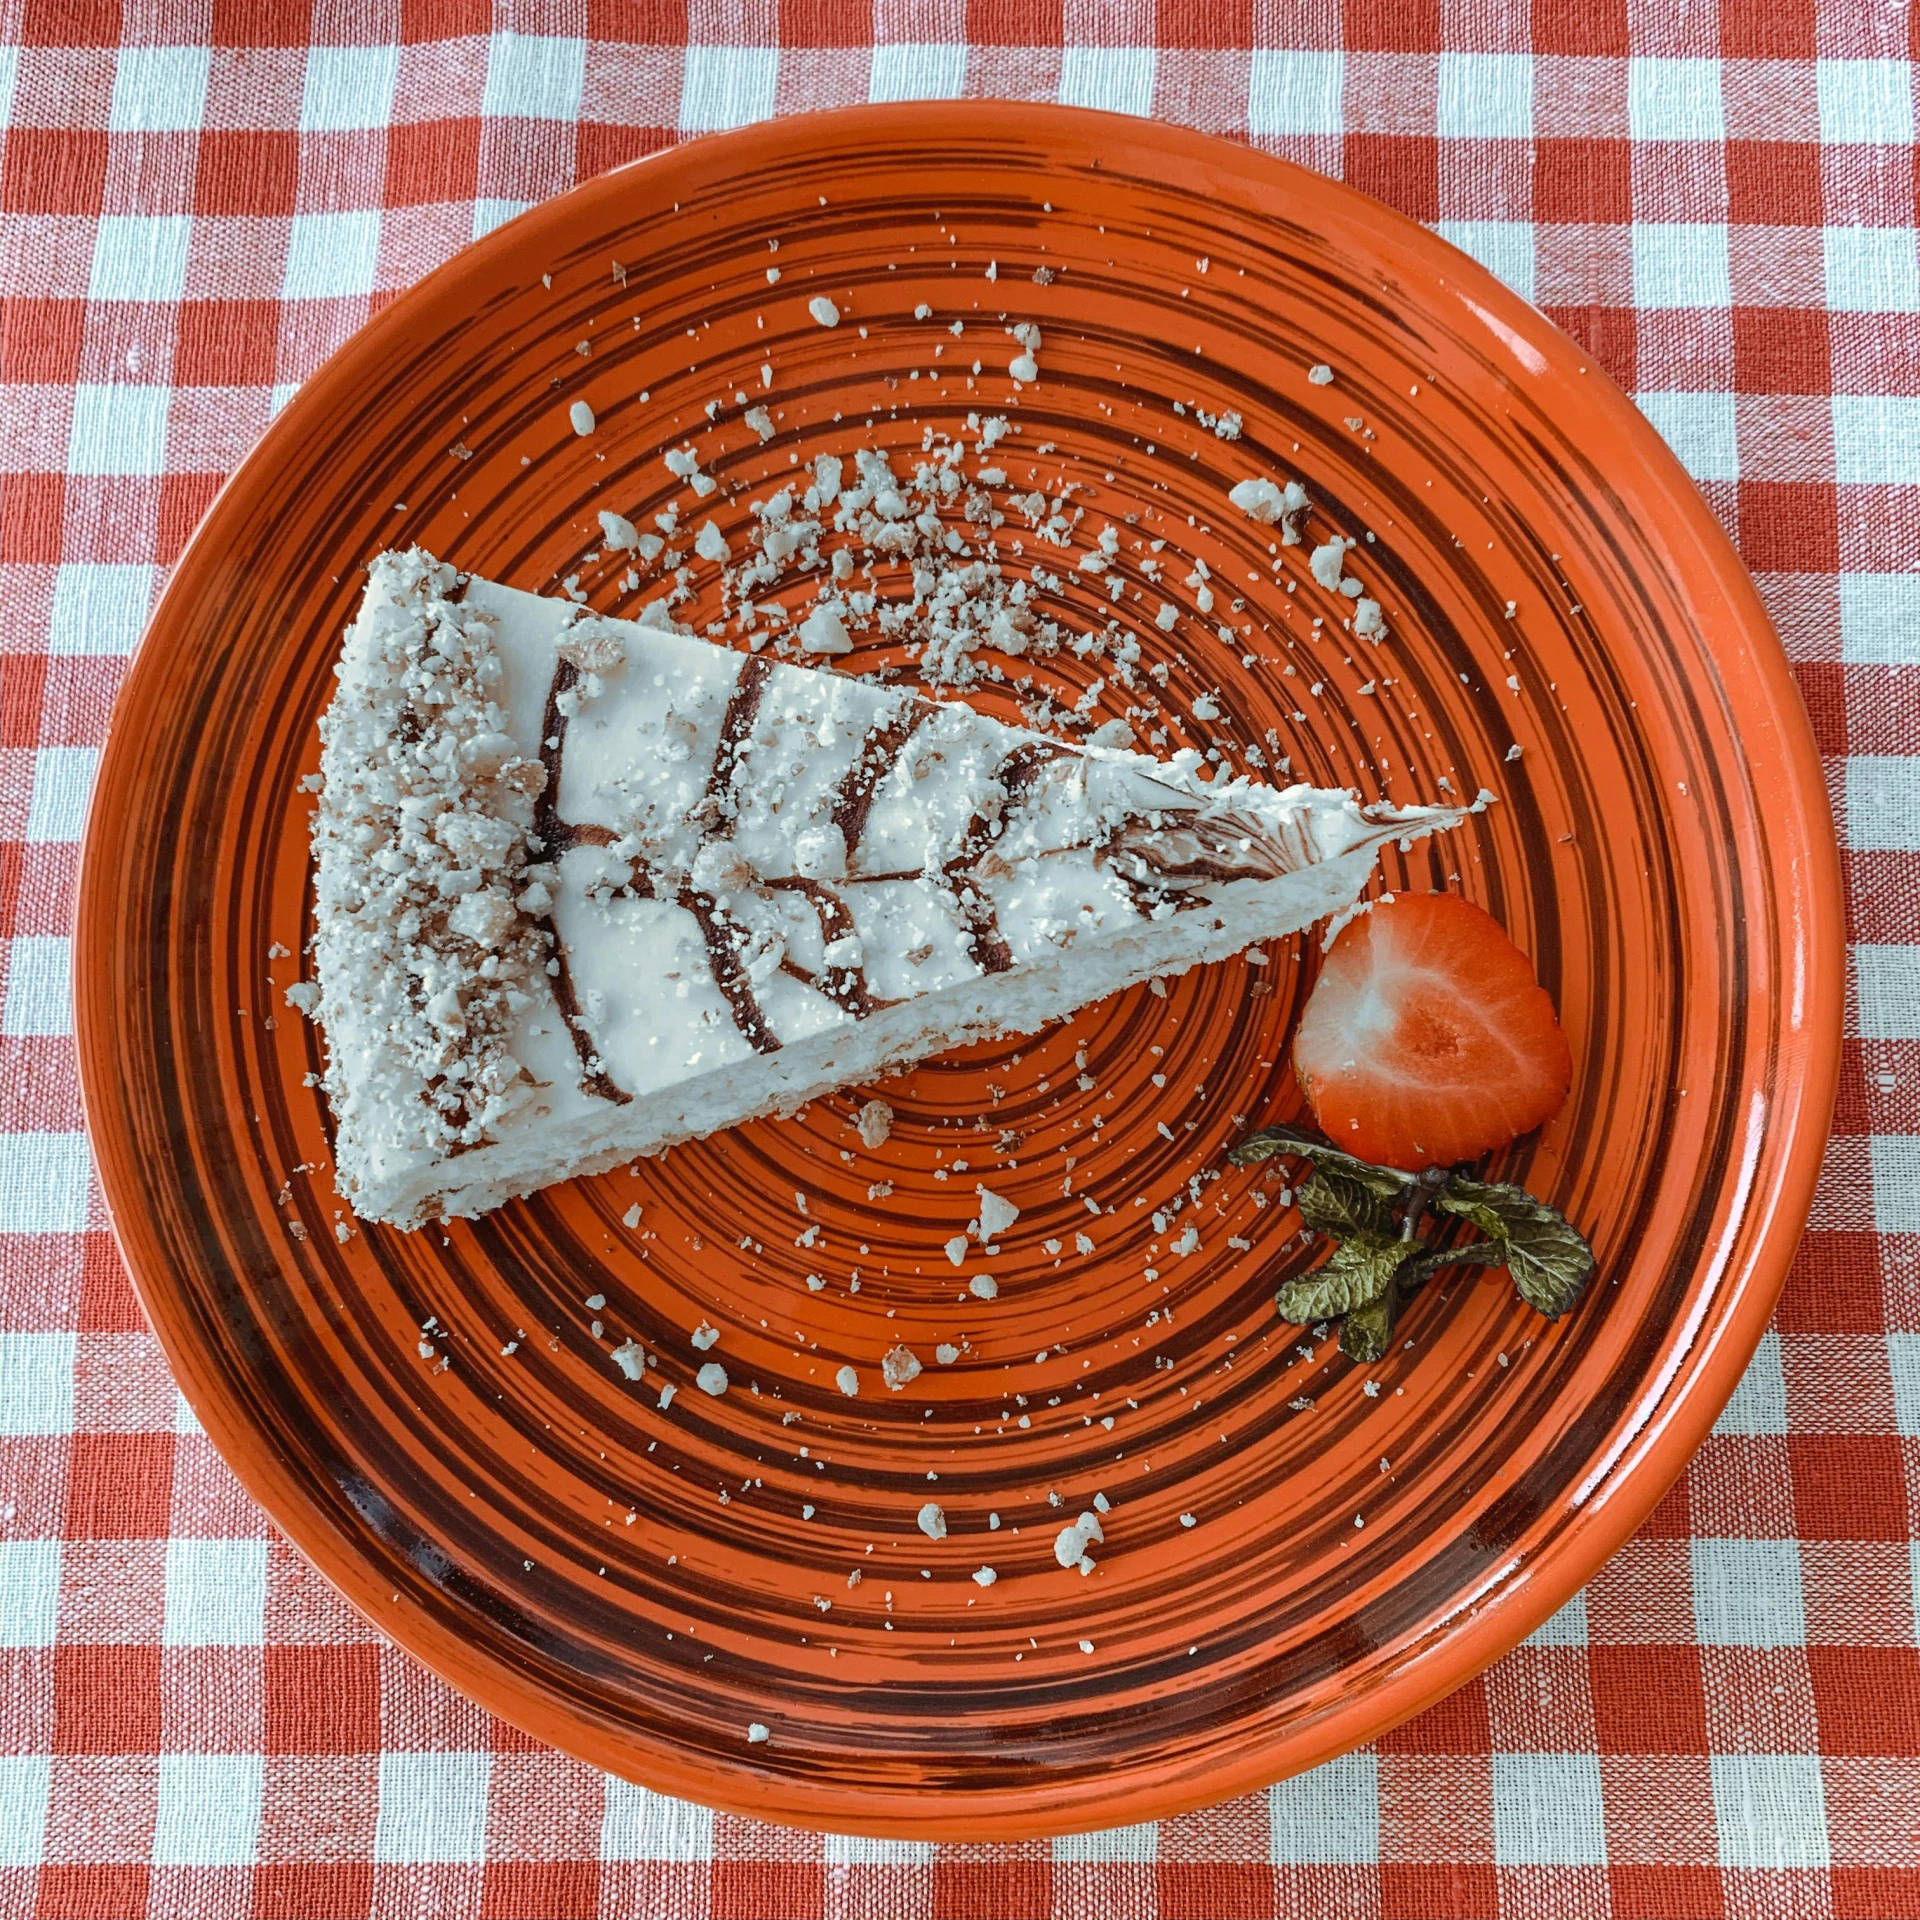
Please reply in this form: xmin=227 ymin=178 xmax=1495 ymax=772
xmin=79 ymin=106 xmax=1841 ymax=1837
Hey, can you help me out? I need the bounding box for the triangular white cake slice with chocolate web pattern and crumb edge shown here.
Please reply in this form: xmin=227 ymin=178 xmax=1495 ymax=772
xmin=303 ymin=551 xmax=1459 ymax=1227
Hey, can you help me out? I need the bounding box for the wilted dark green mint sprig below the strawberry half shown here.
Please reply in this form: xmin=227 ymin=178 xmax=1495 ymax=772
xmin=1227 ymin=1127 xmax=1594 ymax=1365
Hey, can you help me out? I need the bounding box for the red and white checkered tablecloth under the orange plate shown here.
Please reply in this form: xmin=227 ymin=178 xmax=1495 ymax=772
xmin=0 ymin=0 xmax=1920 ymax=1920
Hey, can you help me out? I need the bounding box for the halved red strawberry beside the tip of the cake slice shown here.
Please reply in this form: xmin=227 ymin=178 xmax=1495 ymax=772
xmin=1294 ymin=893 xmax=1572 ymax=1169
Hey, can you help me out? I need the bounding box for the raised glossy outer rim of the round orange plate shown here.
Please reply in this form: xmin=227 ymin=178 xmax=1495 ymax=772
xmin=73 ymin=100 xmax=1847 ymax=1841
